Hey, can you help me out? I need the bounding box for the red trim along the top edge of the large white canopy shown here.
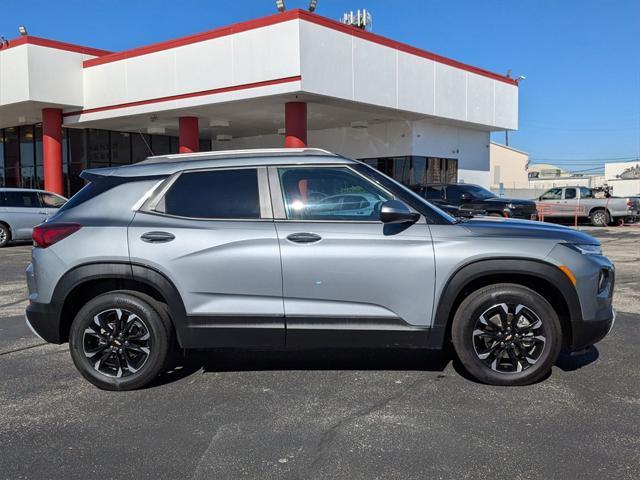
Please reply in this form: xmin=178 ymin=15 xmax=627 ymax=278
xmin=83 ymin=9 xmax=518 ymax=86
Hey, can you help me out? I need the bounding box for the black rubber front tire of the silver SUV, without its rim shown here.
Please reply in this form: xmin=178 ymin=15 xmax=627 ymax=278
xmin=451 ymin=284 xmax=562 ymax=385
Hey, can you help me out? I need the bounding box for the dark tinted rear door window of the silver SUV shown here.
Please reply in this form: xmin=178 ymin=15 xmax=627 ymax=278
xmin=159 ymin=168 xmax=260 ymax=219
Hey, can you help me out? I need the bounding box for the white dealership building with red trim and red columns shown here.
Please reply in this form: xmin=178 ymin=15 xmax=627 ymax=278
xmin=0 ymin=10 xmax=518 ymax=194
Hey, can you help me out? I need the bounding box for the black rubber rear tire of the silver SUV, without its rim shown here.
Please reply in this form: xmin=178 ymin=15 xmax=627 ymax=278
xmin=69 ymin=293 xmax=169 ymax=390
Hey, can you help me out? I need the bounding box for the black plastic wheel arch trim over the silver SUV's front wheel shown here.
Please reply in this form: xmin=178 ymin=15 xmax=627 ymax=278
xmin=428 ymin=258 xmax=582 ymax=349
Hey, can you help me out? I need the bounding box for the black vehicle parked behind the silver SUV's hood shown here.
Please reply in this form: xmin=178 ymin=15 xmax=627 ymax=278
xmin=413 ymin=183 xmax=537 ymax=220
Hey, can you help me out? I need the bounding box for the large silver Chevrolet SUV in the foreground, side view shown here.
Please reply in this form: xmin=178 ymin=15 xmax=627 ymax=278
xmin=27 ymin=149 xmax=614 ymax=390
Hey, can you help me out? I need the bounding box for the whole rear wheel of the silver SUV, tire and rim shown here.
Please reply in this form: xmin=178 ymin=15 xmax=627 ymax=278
xmin=69 ymin=290 xmax=173 ymax=390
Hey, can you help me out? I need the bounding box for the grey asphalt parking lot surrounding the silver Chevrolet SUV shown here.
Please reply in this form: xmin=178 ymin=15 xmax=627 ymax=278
xmin=0 ymin=226 xmax=640 ymax=479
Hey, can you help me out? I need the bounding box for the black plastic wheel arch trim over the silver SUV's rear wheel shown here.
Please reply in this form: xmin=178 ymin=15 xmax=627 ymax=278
xmin=52 ymin=263 xmax=186 ymax=344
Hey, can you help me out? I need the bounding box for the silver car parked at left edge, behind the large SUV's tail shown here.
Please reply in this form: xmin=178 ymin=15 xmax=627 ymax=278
xmin=0 ymin=188 xmax=67 ymax=248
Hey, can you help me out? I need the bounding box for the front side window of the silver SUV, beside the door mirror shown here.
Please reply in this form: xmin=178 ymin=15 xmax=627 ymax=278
xmin=278 ymin=167 xmax=393 ymax=221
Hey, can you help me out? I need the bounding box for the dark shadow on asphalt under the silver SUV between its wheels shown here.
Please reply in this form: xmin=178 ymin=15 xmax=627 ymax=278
xmin=150 ymin=348 xmax=452 ymax=387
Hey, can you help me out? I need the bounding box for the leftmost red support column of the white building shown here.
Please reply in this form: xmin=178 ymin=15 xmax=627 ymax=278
xmin=42 ymin=108 xmax=64 ymax=195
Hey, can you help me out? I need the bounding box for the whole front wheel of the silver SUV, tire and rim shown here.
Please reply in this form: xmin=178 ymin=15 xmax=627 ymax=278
xmin=451 ymin=283 xmax=562 ymax=385
